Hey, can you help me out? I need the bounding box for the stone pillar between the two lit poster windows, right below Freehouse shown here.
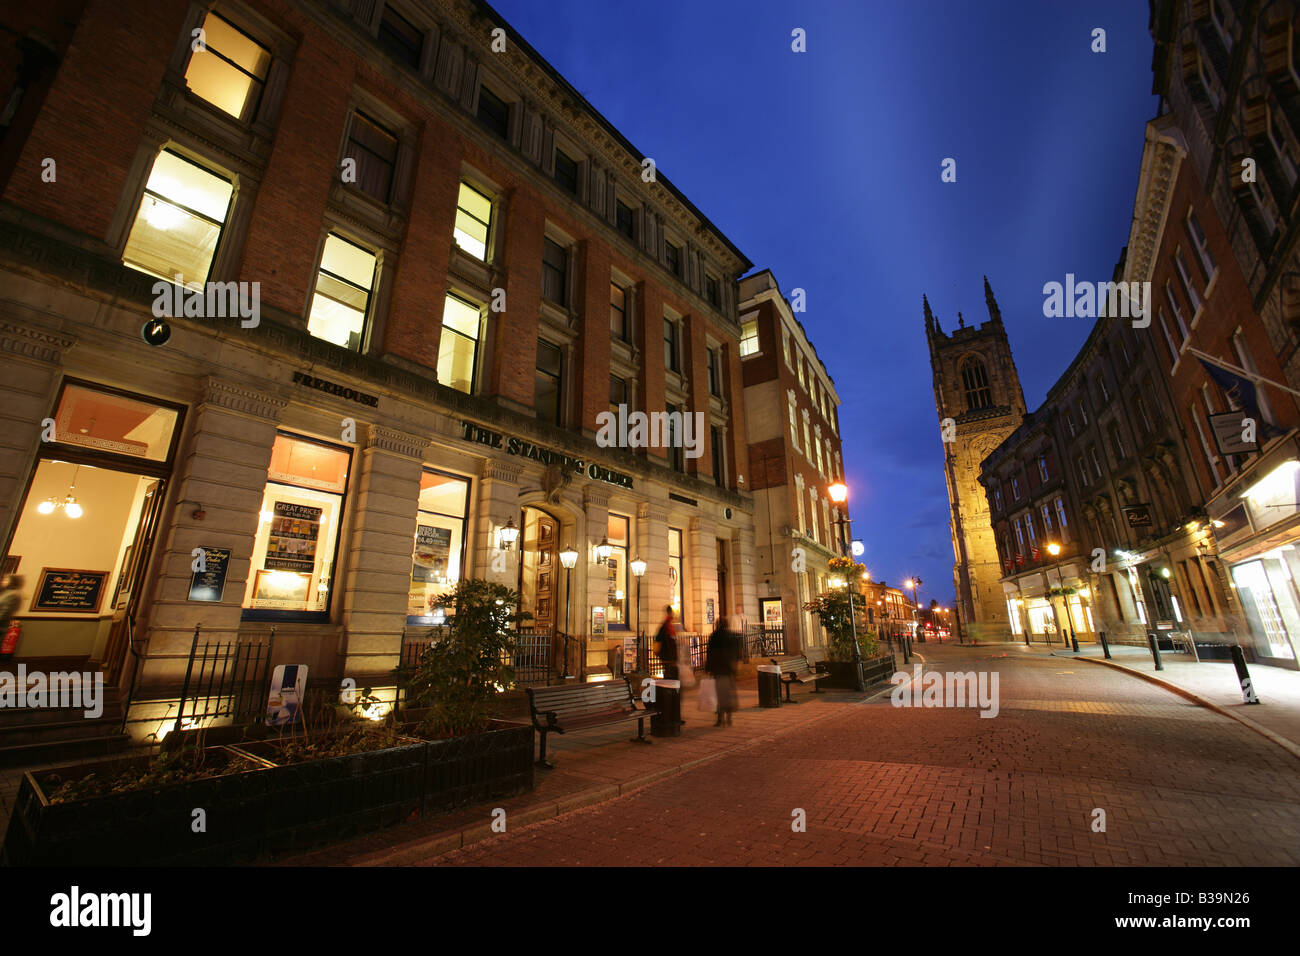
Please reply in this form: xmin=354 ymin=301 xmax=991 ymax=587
xmin=334 ymin=425 xmax=429 ymax=687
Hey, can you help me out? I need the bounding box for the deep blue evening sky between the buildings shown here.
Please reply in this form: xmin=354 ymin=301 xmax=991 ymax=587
xmin=493 ymin=0 xmax=1157 ymax=604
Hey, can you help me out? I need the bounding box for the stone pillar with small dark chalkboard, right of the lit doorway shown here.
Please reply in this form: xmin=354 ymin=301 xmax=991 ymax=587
xmin=137 ymin=376 xmax=287 ymax=688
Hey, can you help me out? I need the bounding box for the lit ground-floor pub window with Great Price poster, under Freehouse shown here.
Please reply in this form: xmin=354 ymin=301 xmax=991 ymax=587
xmin=243 ymin=433 xmax=352 ymax=620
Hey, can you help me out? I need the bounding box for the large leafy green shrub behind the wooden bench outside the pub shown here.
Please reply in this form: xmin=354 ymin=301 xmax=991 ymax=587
xmin=397 ymin=578 xmax=532 ymax=737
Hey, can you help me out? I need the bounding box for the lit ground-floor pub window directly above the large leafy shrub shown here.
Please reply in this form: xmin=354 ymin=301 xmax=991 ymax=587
xmin=407 ymin=468 xmax=469 ymax=626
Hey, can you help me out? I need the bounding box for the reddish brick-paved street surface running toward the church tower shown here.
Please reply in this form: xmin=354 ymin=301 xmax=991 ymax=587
xmin=419 ymin=644 xmax=1300 ymax=866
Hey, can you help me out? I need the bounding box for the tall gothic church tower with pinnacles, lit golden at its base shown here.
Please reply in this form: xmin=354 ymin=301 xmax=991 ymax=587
xmin=920 ymin=276 xmax=1026 ymax=640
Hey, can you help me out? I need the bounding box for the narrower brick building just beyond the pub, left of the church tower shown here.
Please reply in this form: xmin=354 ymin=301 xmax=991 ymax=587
xmin=740 ymin=269 xmax=848 ymax=654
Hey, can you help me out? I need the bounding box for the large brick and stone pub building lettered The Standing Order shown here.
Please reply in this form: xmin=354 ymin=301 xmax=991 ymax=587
xmin=0 ymin=0 xmax=764 ymax=734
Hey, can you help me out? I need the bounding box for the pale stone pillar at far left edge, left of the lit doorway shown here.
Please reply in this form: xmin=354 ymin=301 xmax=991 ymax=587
xmin=0 ymin=319 xmax=77 ymax=546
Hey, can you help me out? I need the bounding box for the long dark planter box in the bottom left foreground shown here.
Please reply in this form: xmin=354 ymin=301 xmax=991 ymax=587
xmin=0 ymin=724 xmax=533 ymax=866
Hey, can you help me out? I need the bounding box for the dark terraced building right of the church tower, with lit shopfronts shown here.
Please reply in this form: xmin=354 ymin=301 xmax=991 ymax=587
xmin=980 ymin=251 xmax=1205 ymax=644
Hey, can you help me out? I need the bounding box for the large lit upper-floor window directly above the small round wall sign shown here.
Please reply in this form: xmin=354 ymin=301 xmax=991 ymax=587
xmin=122 ymin=150 xmax=234 ymax=289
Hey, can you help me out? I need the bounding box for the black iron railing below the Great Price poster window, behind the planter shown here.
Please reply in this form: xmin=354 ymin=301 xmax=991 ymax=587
xmin=176 ymin=624 xmax=276 ymax=730
